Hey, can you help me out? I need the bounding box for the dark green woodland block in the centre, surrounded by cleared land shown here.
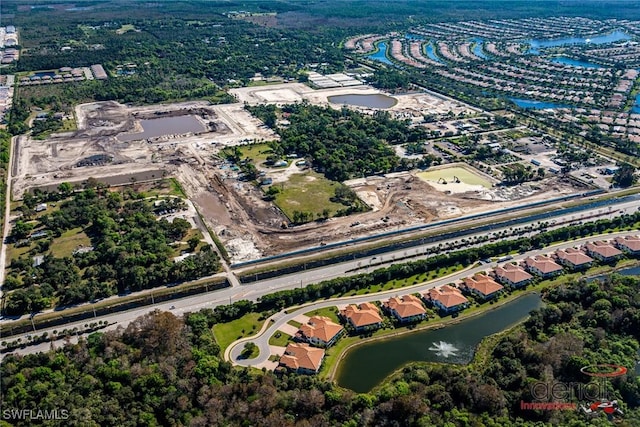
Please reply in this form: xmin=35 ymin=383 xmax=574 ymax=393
xmin=246 ymin=103 xmax=433 ymax=181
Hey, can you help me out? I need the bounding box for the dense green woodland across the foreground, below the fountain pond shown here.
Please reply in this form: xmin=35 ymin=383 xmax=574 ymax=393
xmin=1 ymin=276 xmax=640 ymax=427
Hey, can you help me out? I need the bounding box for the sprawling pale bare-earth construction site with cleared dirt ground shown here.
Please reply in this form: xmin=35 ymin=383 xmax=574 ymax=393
xmin=12 ymin=84 xmax=587 ymax=263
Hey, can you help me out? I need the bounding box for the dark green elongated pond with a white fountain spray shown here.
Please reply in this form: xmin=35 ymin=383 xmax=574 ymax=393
xmin=336 ymin=294 xmax=542 ymax=393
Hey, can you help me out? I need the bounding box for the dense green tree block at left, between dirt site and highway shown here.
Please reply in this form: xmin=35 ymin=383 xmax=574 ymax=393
xmin=3 ymin=184 xmax=220 ymax=315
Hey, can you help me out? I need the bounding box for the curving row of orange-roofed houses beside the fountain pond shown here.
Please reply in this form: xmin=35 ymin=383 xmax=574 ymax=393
xmin=280 ymin=236 xmax=640 ymax=374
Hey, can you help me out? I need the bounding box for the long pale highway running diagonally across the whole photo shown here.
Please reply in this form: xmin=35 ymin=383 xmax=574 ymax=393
xmin=1 ymin=195 xmax=640 ymax=362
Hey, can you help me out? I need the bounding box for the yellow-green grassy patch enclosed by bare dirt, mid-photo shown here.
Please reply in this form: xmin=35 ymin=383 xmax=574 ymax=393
xmin=275 ymin=171 xmax=346 ymax=219
